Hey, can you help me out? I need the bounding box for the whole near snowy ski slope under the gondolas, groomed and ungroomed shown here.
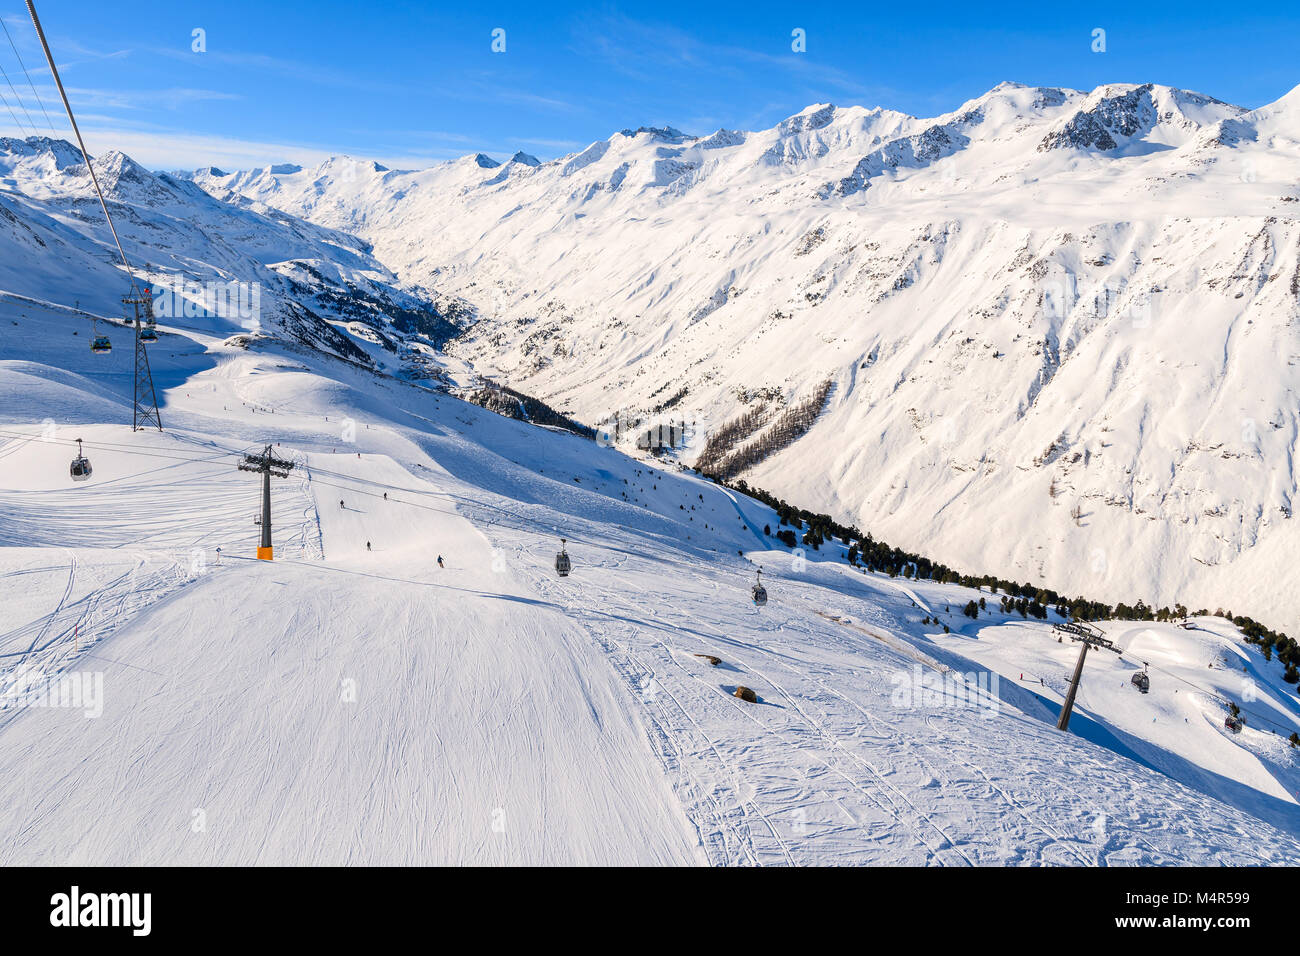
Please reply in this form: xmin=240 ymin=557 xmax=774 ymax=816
xmin=0 ymin=303 xmax=1300 ymax=866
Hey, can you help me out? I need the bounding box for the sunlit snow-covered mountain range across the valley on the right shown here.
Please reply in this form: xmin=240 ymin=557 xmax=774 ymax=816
xmin=194 ymin=83 xmax=1300 ymax=642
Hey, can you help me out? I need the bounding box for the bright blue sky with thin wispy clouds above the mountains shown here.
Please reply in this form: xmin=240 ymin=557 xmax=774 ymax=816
xmin=0 ymin=0 xmax=1300 ymax=168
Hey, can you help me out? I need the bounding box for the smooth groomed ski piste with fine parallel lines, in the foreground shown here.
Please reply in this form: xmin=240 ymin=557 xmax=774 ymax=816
xmin=7 ymin=452 xmax=698 ymax=865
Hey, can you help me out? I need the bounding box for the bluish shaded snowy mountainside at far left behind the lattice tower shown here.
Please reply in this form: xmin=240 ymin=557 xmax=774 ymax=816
xmin=0 ymin=137 xmax=459 ymax=363
